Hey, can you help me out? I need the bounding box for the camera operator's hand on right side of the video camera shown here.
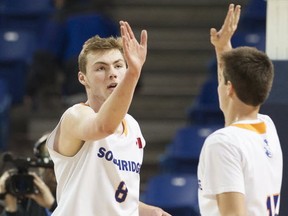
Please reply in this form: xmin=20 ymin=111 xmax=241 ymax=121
xmin=27 ymin=173 xmax=55 ymax=209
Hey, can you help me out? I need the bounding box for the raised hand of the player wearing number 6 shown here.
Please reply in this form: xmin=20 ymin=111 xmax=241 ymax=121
xmin=120 ymin=21 xmax=148 ymax=73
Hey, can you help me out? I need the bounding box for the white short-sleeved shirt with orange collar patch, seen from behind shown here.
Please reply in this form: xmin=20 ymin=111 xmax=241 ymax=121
xmin=198 ymin=114 xmax=283 ymax=216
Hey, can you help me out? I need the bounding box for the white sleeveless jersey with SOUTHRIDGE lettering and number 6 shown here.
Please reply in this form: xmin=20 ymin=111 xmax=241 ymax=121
xmin=47 ymin=109 xmax=145 ymax=216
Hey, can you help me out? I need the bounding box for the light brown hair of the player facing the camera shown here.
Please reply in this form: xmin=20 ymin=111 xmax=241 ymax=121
xmin=78 ymin=35 xmax=123 ymax=74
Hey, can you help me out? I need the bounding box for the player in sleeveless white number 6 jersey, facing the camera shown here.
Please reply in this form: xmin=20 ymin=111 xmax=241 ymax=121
xmin=47 ymin=21 xmax=169 ymax=216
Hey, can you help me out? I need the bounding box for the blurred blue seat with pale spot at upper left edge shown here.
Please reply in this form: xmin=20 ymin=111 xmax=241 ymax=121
xmin=0 ymin=29 xmax=36 ymax=104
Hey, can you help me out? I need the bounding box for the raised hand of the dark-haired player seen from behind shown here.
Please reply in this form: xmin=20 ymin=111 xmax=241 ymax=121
xmin=210 ymin=4 xmax=241 ymax=51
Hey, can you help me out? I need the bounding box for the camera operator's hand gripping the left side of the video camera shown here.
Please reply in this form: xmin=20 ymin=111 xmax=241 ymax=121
xmin=0 ymin=171 xmax=18 ymax=213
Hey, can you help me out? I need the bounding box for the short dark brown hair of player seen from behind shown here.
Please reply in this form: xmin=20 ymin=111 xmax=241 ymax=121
xmin=221 ymin=47 xmax=274 ymax=106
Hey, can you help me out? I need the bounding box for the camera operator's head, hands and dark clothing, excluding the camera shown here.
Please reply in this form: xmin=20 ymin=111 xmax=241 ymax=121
xmin=0 ymin=134 xmax=57 ymax=216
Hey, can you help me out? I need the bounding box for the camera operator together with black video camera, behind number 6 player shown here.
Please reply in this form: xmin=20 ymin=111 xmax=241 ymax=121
xmin=0 ymin=135 xmax=57 ymax=216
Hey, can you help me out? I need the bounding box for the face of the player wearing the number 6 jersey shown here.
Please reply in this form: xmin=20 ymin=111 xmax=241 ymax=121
xmin=81 ymin=49 xmax=127 ymax=101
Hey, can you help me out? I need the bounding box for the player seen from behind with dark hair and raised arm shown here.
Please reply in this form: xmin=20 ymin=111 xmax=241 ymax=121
xmin=198 ymin=4 xmax=282 ymax=216
